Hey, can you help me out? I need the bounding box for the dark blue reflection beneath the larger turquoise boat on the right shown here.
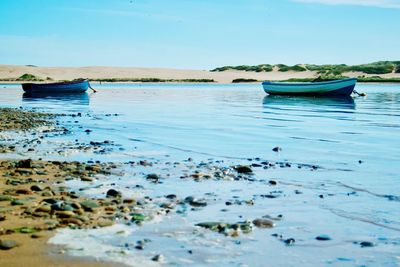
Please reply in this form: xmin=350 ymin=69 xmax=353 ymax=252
xmin=263 ymin=95 xmax=356 ymax=110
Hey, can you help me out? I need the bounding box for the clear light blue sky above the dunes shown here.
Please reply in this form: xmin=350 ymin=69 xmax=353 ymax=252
xmin=0 ymin=0 xmax=400 ymax=69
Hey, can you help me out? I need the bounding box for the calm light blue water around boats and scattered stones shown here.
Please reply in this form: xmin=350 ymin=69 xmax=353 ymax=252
xmin=0 ymin=84 xmax=400 ymax=266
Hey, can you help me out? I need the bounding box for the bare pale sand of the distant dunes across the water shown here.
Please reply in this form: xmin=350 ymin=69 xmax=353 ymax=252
xmin=0 ymin=65 xmax=400 ymax=84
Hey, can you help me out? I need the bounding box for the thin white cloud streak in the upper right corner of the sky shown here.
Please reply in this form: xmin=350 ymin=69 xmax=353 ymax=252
xmin=292 ymin=0 xmax=400 ymax=8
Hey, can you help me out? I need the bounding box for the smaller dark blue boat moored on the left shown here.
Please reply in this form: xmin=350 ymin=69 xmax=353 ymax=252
xmin=22 ymin=79 xmax=90 ymax=94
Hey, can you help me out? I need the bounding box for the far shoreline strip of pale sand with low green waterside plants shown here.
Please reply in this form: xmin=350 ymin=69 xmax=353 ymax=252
xmin=0 ymin=65 xmax=400 ymax=84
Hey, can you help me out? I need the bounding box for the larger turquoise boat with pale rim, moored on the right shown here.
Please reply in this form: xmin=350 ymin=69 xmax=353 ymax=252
xmin=262 ymin=78 xmax=357 ymax=96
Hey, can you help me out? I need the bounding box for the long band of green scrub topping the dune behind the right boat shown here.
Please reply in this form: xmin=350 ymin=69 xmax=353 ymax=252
xmin=211 ymin=61 xmax=400 ymax=76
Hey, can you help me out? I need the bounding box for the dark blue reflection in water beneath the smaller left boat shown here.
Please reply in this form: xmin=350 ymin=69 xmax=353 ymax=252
xmin=22 ymin=93 xmax=89 ymax=106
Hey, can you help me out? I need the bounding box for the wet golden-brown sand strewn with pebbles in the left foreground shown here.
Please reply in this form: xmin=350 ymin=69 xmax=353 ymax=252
xmin=0 ymin=108 xmax=121 ymax=267
